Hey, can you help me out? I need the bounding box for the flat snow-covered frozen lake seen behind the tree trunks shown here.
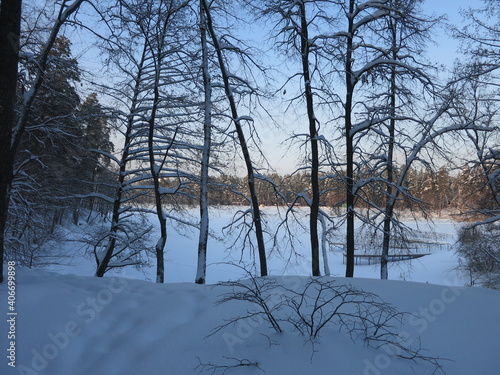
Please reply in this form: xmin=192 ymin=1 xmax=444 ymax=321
xmin=47 ymin=207 xmax=467 ymax=285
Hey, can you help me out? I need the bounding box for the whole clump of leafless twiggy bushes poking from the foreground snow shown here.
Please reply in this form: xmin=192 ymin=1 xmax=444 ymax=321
xmin=210 ymin=271 xmax=444 ymax=373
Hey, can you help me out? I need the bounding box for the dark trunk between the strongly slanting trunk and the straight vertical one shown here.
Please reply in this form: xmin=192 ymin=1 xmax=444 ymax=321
xmin=299 ymin=2 xmax=321 ymax=276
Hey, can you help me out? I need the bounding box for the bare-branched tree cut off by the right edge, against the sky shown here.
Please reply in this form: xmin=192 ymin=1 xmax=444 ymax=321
xmin=454 ymin=0 xmax=500 ymax=224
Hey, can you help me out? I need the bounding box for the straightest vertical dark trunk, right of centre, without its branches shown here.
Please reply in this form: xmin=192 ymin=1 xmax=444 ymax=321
xmin=344 ymin=0 xmax=355 ymax=277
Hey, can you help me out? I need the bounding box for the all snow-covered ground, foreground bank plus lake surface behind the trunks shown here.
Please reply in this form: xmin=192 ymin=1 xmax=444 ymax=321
xmin=0 ymin=207 xmax=500 ymax=375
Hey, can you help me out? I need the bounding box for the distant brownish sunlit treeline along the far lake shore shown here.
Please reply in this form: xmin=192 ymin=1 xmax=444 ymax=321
xmin=147 ymin=166 xmax=495 ymax=219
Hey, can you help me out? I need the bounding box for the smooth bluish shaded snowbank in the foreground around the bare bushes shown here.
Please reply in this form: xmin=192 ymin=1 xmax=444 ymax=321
xmin=0 ymin=269 xmax=500 ymax=375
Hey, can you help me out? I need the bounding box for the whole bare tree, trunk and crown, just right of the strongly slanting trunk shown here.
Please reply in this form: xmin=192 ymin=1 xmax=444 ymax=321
xmin=253 ymin=0 xmax=342 ymax=276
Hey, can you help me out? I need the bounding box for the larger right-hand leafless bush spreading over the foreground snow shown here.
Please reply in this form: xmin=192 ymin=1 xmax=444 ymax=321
xmin=284 ymin=278 xmax=442 ymax=372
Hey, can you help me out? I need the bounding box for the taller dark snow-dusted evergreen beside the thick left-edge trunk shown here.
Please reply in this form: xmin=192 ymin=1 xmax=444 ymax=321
xmin=17 ymin=37 xmax=83 ymax=196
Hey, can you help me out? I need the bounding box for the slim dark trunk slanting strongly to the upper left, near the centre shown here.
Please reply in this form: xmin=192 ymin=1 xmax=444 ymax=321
xmin=202 ymin=0 xmax=267 ymax=276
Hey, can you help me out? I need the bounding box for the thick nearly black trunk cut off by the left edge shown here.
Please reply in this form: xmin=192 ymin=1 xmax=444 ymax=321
xmin=0 ymin=0 xmax=21 ymax=282
